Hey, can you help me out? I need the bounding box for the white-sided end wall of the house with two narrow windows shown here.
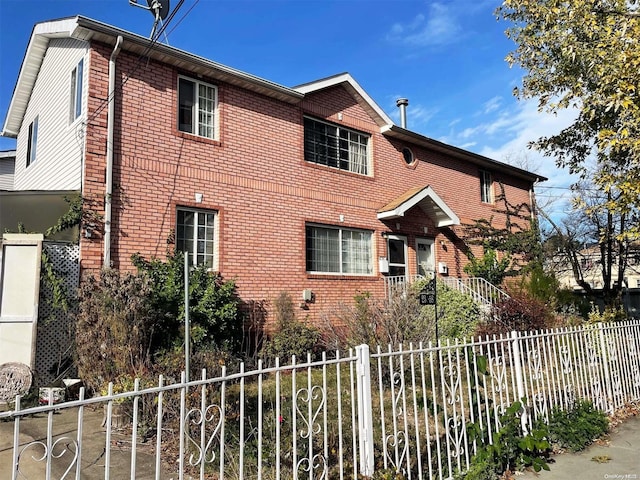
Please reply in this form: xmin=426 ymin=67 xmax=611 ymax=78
xmin=14 ymin=33 xmax=89 ymax=190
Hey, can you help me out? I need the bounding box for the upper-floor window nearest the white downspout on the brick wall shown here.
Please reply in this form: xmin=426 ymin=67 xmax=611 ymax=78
xmin=178 ymin=77 xmax=218 ymax=138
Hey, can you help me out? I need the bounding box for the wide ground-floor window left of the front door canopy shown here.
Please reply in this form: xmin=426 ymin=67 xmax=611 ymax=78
xmin=306 ymin=225 xmax=373 ymax=275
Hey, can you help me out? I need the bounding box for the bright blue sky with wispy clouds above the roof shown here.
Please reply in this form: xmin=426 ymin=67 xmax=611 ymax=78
xmin=0 ymin=0 xmax=575 ymax=218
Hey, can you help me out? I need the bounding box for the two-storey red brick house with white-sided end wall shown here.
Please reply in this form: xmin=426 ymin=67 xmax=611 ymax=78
xmin=2 ymin=17 xmax=544 ymax=317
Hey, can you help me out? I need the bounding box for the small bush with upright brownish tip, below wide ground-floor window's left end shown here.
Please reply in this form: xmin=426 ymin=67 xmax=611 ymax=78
xmin=261 ymin=292 xmax=320 ymax=359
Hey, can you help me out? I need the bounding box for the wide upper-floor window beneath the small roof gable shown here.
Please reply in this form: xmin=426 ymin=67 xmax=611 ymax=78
xmin=304 ymin=118 xmax=369 ymax=175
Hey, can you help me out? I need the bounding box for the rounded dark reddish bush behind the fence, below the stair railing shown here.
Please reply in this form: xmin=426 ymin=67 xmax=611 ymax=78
xmin=476 ymin=291 xmax=556 ymax=336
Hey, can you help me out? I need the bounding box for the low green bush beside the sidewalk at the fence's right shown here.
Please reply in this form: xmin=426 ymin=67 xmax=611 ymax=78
xmin=548 ymin=400 xmax=609 ymax=452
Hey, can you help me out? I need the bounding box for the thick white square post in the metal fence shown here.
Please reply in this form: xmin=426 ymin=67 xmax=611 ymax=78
xmin=356 ymin=345 xmax=373 ymax=477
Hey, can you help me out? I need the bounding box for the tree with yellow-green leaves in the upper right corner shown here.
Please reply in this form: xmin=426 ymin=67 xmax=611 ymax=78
xmin=496 ymin=0 xmax=640 ymax=238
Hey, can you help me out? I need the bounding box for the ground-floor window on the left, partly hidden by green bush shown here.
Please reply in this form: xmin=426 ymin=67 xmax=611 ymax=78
xmin=176 ymin=208 xmax=216 ymax=269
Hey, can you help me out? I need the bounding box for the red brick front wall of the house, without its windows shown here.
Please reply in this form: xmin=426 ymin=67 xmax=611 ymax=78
xmin=82 ymin=45 xmax=529 ymax=326
